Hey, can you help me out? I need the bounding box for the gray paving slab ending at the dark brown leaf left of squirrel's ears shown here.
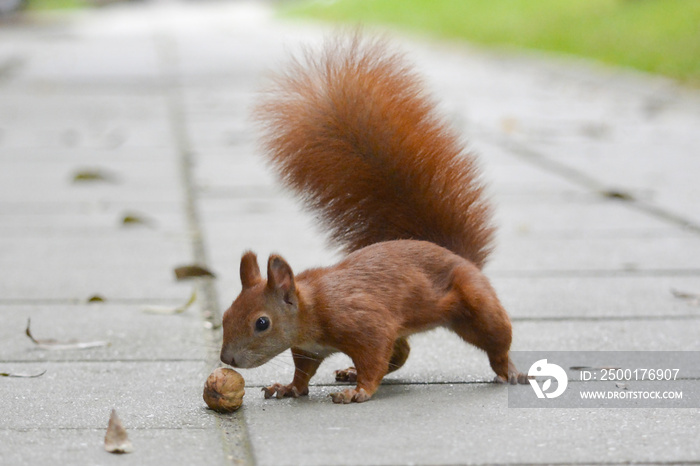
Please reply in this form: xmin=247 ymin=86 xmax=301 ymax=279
xmin=0 ymin=232 xmax=191 ymax=300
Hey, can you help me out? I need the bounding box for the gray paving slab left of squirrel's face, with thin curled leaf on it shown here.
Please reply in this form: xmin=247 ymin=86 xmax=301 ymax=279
xmin=0 ymin=304 xmax=208 ymax=364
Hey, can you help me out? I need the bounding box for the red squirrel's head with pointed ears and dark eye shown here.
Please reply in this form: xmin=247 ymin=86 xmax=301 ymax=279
xmin=221 ymin=252 xmax=299 ymax=368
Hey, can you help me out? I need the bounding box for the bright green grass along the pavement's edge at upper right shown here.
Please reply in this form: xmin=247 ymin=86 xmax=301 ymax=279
xmin=285 ymin=0 xmax=700 ymax=85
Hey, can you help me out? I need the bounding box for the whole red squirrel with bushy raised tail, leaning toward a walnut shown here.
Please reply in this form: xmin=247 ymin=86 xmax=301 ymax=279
xmin=221 ymin=35 xmax=527 ymax=403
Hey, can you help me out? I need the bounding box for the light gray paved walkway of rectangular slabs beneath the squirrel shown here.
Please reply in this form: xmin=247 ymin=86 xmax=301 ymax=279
xmin=0 ymin=1 xmax=700 ymax=465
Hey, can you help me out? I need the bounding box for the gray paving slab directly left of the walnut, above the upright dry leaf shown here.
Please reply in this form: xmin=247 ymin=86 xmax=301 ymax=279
xmin=0 ymin=361 xmax=216 ymax=431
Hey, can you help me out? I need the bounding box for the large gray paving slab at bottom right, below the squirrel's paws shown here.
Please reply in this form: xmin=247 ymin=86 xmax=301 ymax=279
xmin=245 ymin=384 xmax=699 ymax=464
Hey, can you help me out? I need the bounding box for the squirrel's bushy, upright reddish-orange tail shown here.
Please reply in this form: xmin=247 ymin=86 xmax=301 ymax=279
xmin=255 ymin=35 xmax=493 ymax=267
